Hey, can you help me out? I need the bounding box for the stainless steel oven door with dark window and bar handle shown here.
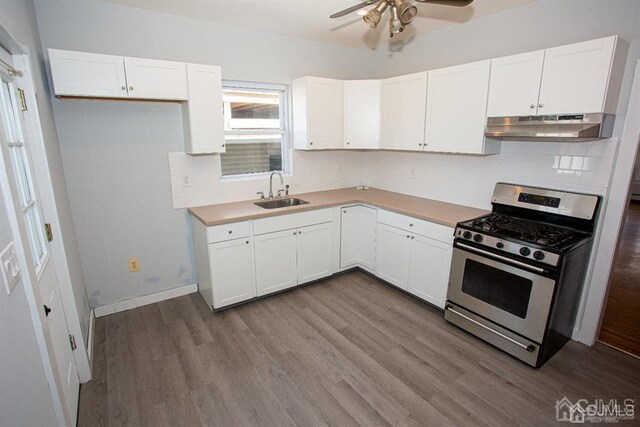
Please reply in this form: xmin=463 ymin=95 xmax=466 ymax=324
xmin=447 ymin=243 xmax=556 ymax=343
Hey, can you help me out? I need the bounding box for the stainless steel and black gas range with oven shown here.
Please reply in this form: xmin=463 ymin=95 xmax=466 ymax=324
xmin=444 ymin=183 xmax=600 ymax=368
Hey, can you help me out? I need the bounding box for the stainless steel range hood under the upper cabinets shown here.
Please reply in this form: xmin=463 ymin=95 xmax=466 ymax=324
xmin=484 ymin=113 xmax=615 ymax=142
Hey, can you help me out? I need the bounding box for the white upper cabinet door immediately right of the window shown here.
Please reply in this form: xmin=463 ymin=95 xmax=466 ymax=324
xmin=307 ymin=77 xmax=344 ymax=149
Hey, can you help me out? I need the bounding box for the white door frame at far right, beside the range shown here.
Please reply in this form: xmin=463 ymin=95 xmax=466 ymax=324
xmin=576 ymin=60 xmax=640 ymax=346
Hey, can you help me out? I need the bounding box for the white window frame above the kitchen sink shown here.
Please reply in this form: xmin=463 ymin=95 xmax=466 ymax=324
xmin=219 ymin=80 xmax=291 ymax=182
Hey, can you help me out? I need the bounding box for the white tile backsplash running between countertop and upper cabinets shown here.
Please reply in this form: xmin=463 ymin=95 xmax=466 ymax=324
xmin=169 ymin=138 xmax=618 ymax=209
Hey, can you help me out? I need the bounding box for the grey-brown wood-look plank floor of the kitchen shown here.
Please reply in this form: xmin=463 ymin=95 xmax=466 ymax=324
xmin=79 ymin=272 xmax=640 ymax=426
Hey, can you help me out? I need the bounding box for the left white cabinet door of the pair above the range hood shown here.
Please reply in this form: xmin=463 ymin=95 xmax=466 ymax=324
xmin=487 ymin=50 xmax=544 ymax=117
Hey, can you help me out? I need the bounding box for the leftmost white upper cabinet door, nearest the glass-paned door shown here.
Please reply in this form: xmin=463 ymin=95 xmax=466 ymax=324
xmin=49 ymin=49 xmax=127 ymax=98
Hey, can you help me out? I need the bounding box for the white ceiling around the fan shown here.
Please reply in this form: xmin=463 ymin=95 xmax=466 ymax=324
xmin=104 ymin=0 xmax=535 ymax=49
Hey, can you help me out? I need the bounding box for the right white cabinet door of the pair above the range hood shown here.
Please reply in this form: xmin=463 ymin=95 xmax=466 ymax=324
xmin=538 ymin=37 xmax=617 ymax=114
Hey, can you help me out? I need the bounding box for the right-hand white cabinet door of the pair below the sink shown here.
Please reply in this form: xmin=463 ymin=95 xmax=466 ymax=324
xmin=297 ymin=222 xmax=333 ymax=285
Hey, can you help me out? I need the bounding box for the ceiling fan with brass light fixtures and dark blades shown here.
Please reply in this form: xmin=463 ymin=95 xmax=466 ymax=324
xmin=329 ymin=0 xmax=473 ymax=37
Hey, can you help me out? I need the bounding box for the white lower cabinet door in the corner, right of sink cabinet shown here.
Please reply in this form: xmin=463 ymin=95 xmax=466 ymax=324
xmin=340 ymin=205 xmax=378 ymax=271
